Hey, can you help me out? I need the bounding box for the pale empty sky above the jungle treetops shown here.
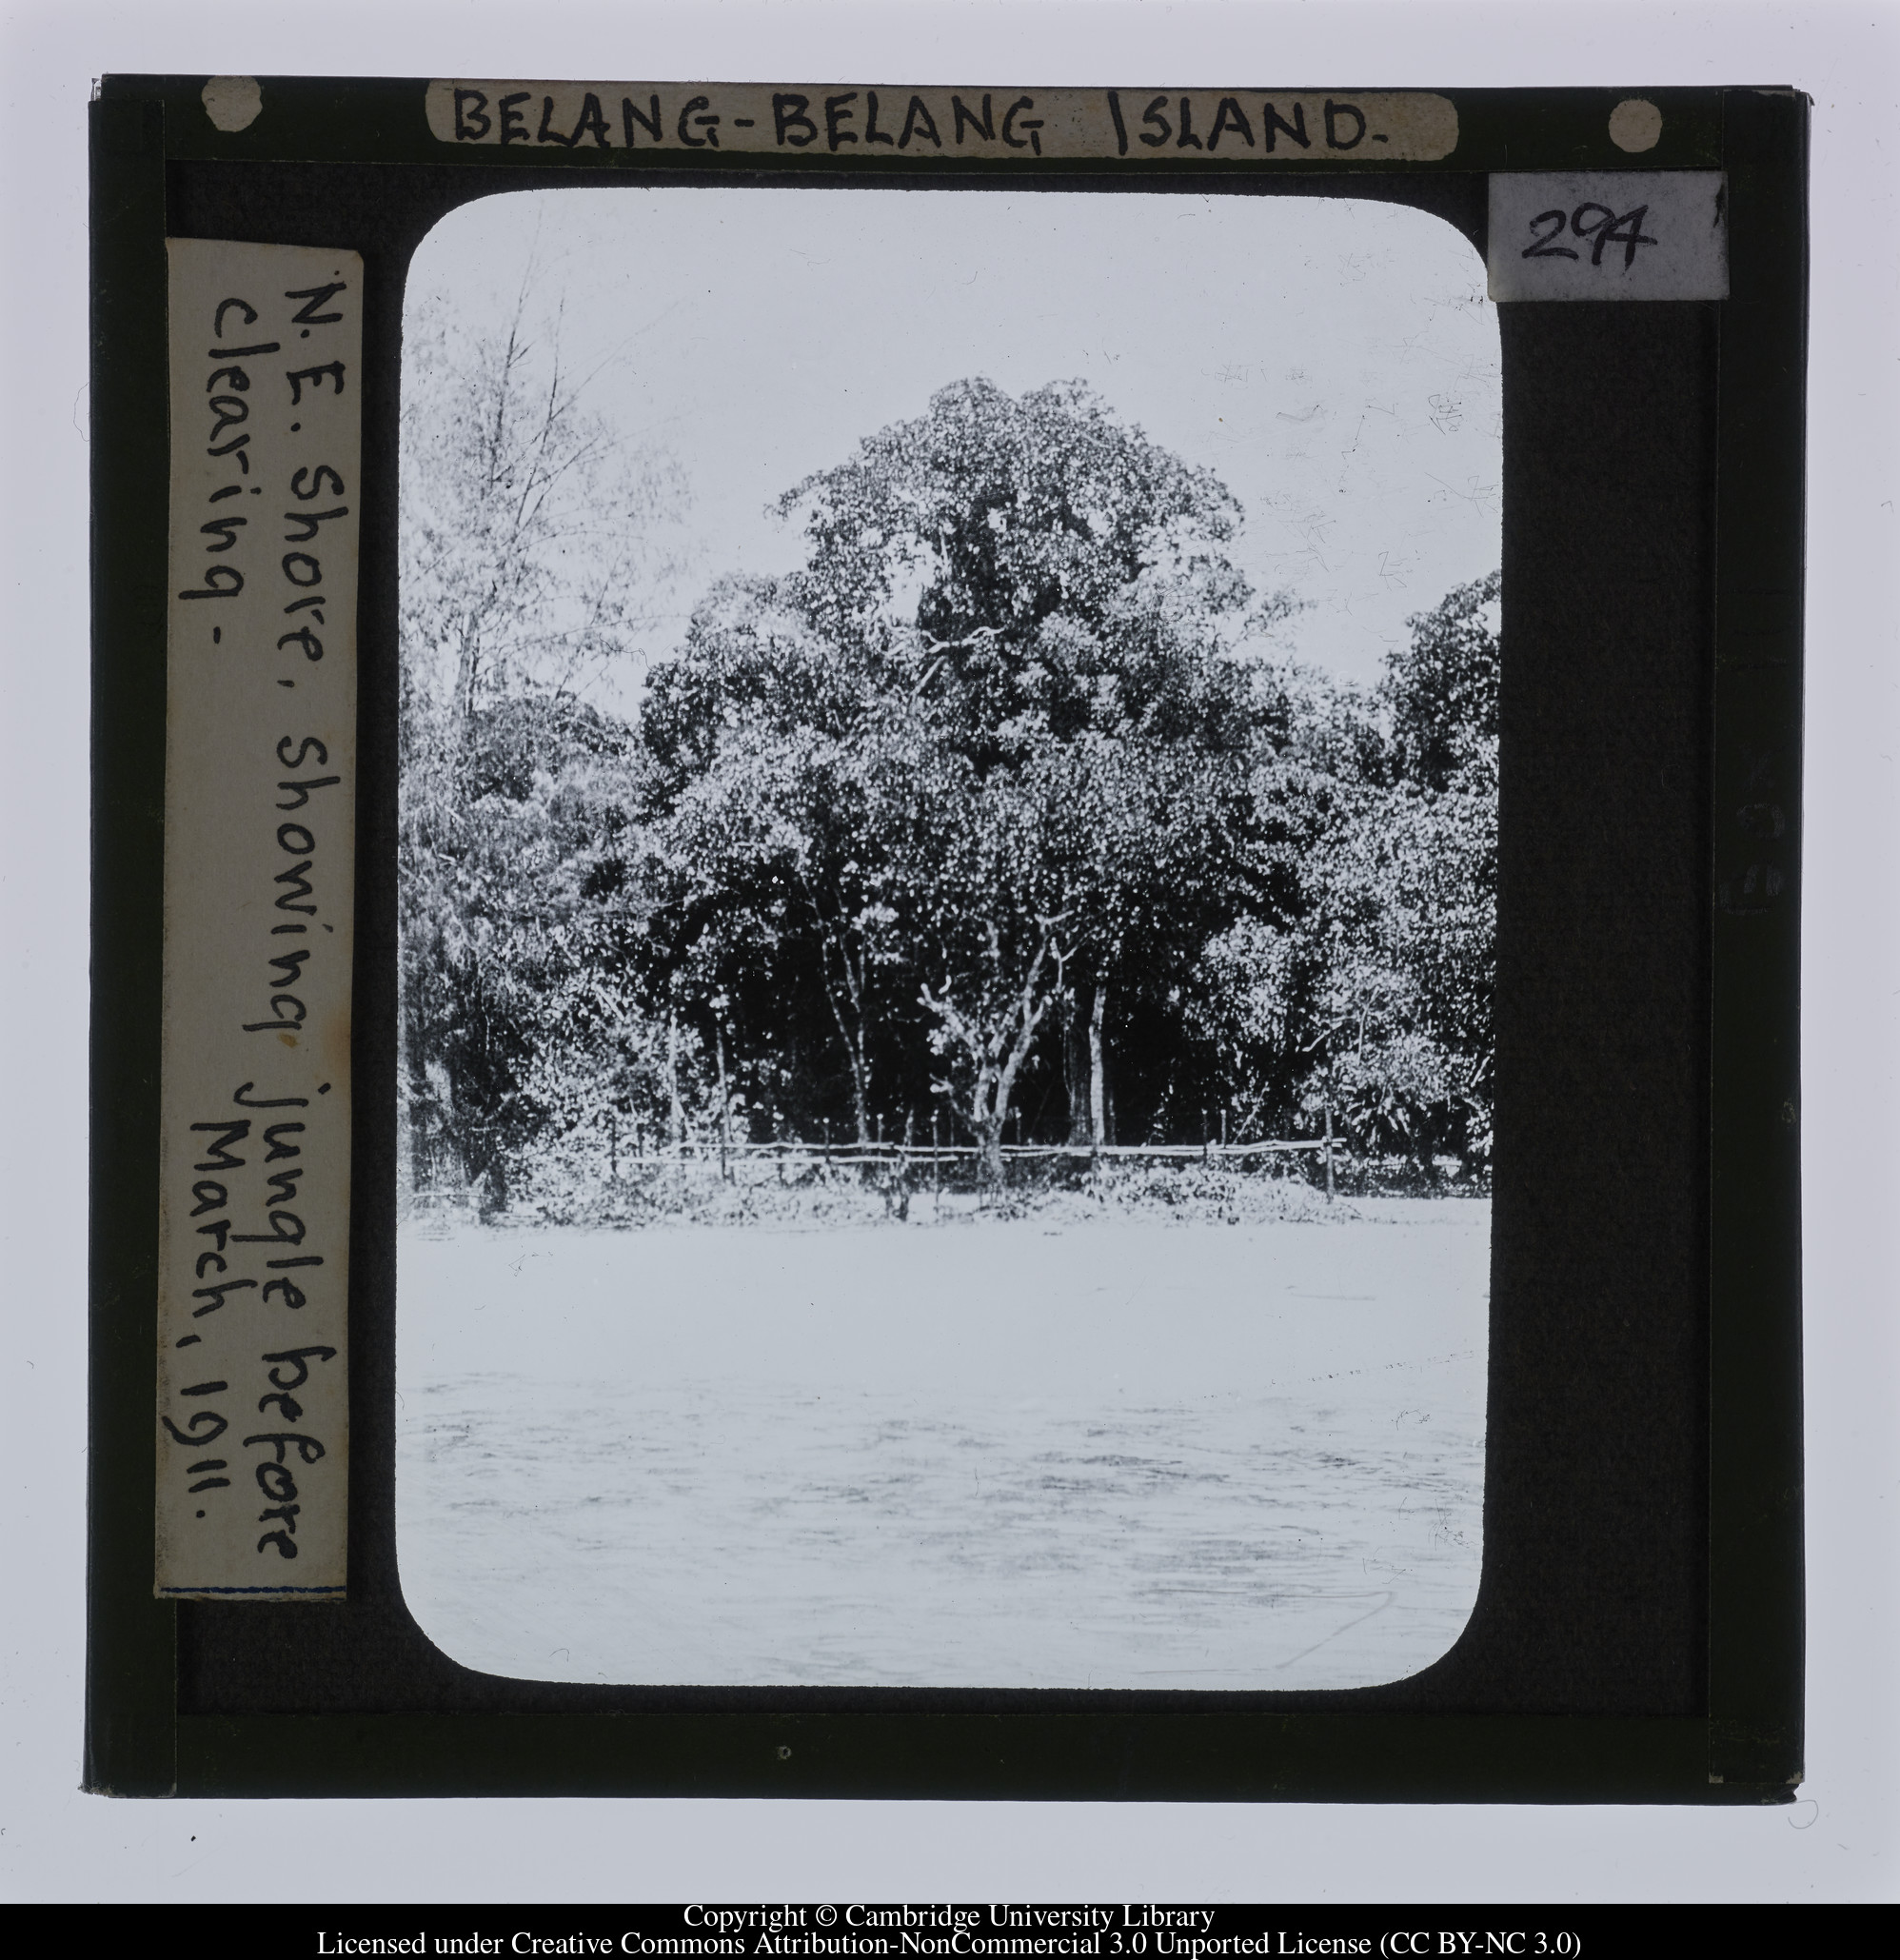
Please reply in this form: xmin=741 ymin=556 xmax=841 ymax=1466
xmin=407 ymin=187 xmax=1502 ymax=680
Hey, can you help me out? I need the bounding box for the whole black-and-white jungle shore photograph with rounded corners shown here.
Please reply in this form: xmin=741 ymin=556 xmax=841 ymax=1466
xmin=396 ymin=187 xmax=1502 ymax=1692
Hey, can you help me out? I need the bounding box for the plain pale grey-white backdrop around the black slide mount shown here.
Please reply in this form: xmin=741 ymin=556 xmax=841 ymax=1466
xmin=0 ymin=0 xmax=1900 ymax=1903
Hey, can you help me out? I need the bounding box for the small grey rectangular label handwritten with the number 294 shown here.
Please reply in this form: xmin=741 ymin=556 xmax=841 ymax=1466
xmin=1488 ymin=170 xmax=1730 ymax=300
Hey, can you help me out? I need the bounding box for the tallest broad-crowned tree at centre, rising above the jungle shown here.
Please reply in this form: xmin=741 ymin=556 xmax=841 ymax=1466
xmin=764 ymin=380 xmax=1288 ymax=1153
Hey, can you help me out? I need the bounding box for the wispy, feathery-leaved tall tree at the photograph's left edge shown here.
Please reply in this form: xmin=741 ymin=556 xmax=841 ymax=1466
xmin=398 ymin=280 xmax=684 ymax=1192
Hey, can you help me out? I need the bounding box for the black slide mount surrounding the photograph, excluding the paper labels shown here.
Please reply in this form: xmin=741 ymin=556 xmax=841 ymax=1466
xmin=87 ymin=76 xmax=1806 ymax=1803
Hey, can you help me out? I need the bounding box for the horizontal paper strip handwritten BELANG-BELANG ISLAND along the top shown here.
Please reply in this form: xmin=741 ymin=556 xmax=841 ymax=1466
xmin=427 ymin=80 xmax=1459 ymax=163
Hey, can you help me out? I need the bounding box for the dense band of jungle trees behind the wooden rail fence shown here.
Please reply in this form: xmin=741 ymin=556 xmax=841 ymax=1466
xmin=404 ymin=360 xmax=1498 ymax=1194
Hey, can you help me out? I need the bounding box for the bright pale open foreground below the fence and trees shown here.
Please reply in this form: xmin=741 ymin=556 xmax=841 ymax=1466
xmin=398 ymin=1201 xmax=1490 ymax=1688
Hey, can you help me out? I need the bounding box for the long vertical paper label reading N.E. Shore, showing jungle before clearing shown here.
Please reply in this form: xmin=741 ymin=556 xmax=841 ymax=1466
xmin=157 ymin=239 xmax=363 ymax=1599
